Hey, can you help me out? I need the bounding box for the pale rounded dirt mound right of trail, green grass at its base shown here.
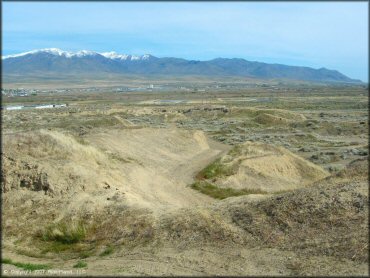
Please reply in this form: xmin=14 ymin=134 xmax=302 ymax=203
xmin=213 ymin=142 xmax=329 ymax=192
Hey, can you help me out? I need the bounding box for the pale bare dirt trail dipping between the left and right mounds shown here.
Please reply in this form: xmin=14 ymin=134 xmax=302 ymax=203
xmin=86 ymin=128 xmax=229 ymax=212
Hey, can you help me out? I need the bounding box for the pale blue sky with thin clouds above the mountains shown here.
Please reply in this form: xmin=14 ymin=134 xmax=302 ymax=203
xmin=2 ymin=1 xmax=369 ymax=82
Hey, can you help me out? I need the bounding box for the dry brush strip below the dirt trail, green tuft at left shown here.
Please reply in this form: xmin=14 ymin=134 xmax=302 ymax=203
xmin=27 ymin=206 xmax=245 ymax=258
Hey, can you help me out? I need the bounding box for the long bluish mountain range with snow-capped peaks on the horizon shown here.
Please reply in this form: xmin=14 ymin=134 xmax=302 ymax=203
xmin=2 ymin=48 xmax=361 ymax=83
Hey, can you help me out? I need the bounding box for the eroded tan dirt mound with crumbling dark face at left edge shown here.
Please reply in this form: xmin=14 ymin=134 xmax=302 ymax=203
xmin=2 ymin=130 xmax=109 ymax=196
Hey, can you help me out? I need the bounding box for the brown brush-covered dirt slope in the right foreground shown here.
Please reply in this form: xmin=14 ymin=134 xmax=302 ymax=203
xmin=217 ymin=178 xmax=369 ymax=262
